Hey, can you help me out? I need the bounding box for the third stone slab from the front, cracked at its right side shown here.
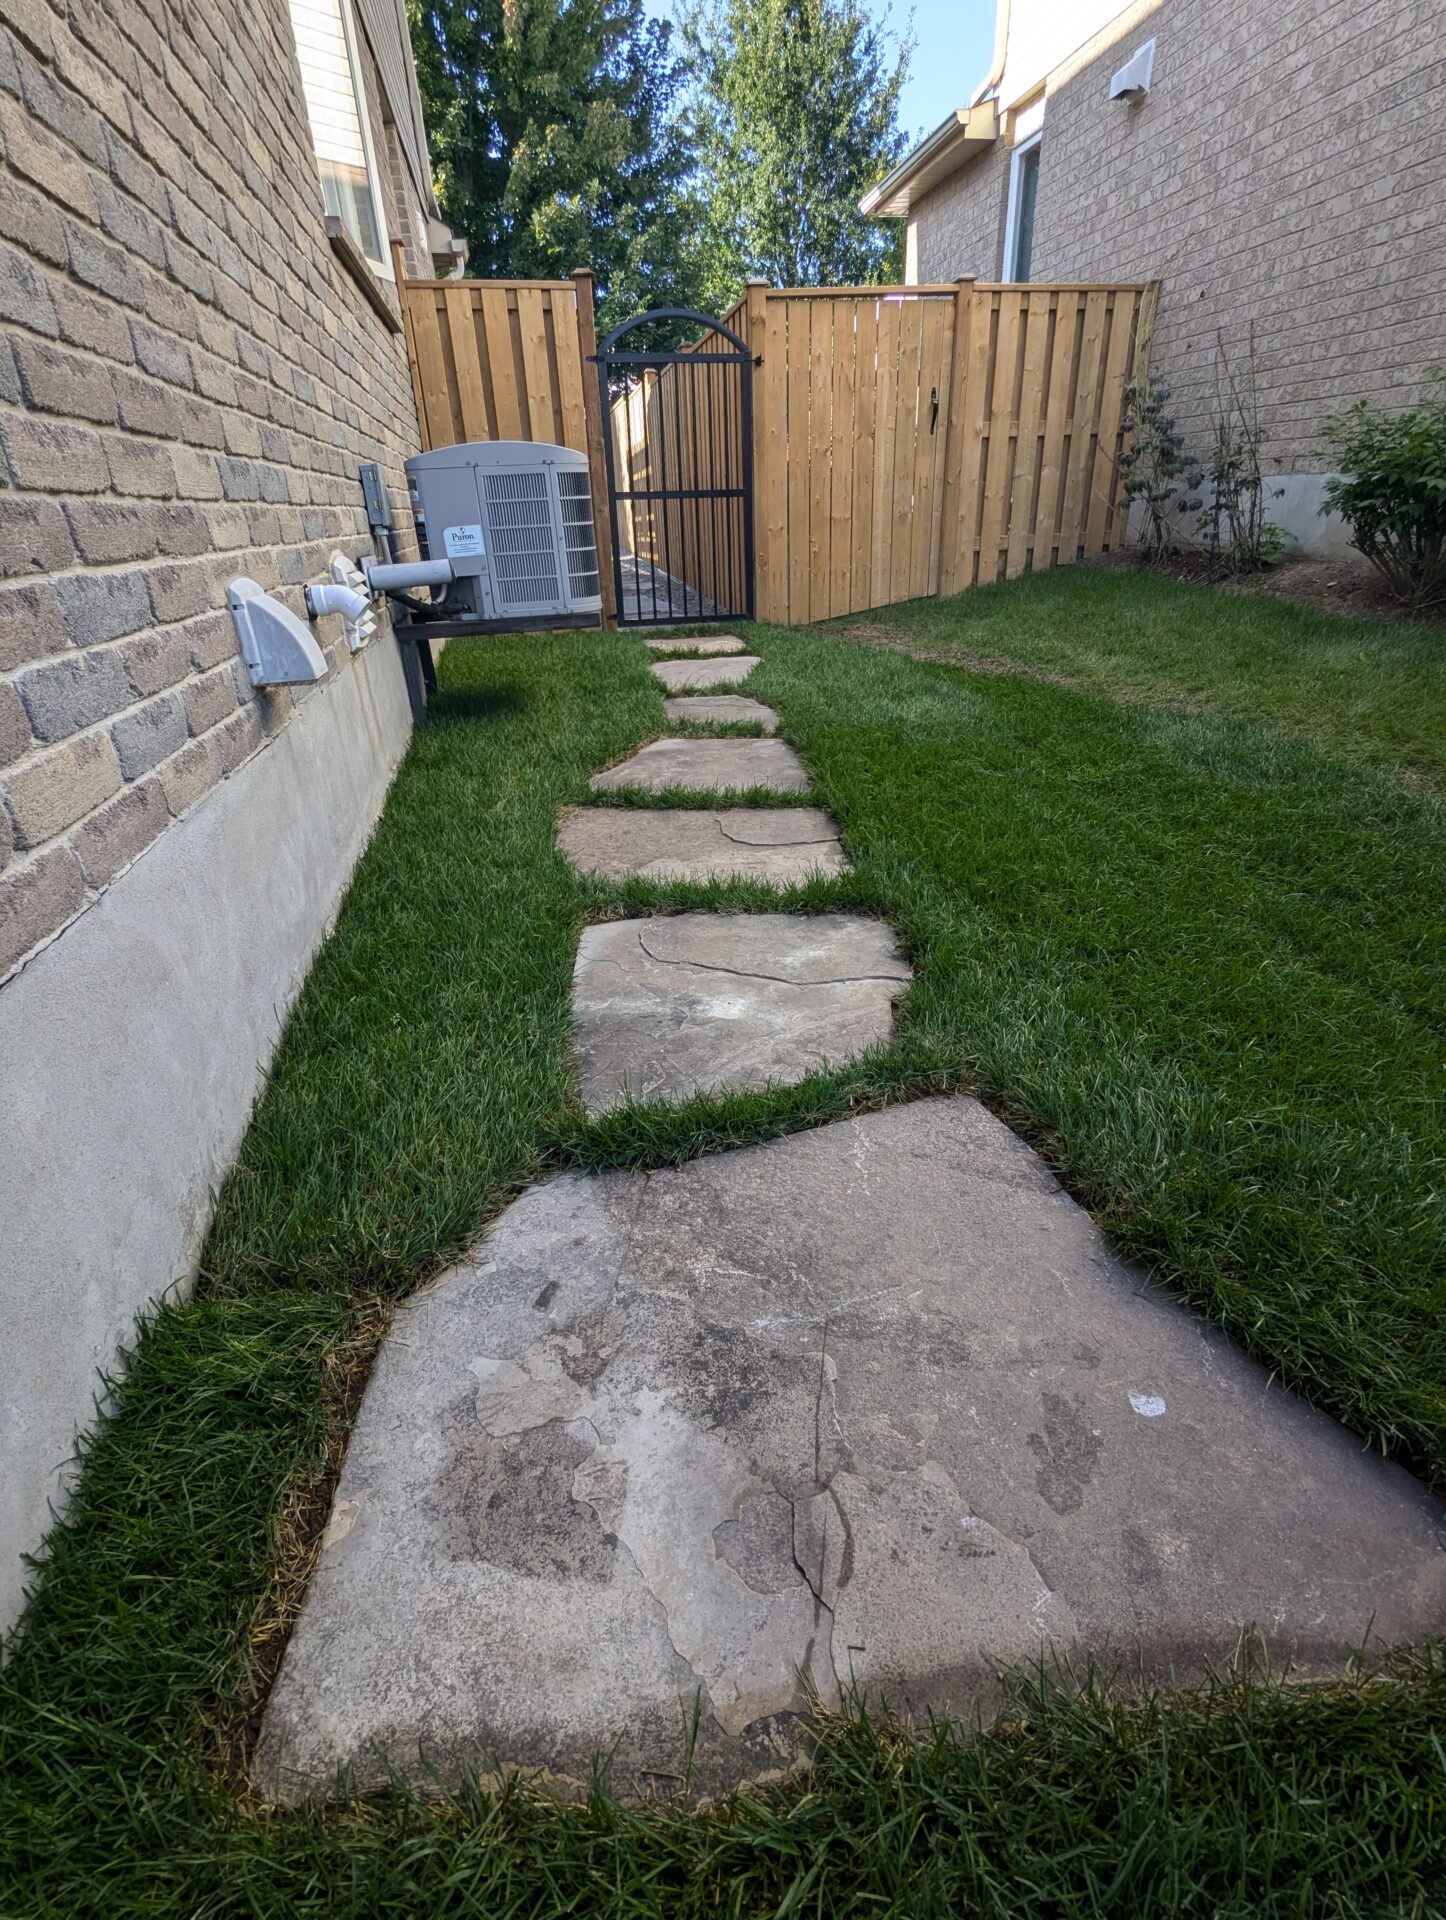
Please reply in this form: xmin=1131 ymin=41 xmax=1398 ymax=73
xmin=557 ymin=806 xmax=849 ymax=885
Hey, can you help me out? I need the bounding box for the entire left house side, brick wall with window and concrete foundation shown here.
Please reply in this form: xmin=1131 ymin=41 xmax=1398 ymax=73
xmin=0 ymin=0 xmax=459 ymax=1624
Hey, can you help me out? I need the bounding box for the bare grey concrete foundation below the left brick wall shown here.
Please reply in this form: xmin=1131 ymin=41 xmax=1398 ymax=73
xmin=0 ymin=637 xmax=411 ymax=1624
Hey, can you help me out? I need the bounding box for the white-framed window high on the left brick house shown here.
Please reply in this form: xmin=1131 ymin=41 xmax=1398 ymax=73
xmin=292 ymin=0 xmax=392 ymax=280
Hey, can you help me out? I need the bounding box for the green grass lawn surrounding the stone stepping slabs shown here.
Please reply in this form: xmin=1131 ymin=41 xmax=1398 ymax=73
xmin=0 ymin=572 xmax=1446 ymax=1920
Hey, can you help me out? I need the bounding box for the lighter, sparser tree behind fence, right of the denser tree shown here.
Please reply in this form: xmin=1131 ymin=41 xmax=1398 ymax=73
xmin=682 ymin=0 xmax=908 ymax=311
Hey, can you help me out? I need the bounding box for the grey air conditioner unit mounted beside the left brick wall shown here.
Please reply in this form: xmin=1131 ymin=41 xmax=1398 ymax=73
xmin=407 ymin=440 xmax=603 ymax=628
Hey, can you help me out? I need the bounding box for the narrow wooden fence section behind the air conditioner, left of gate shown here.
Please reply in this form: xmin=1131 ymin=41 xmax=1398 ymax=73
xmin=394 ymin=261 xmax=616 ymax=620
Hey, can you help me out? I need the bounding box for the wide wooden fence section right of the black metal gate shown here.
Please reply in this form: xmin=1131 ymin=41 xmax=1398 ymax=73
xmin=730 ymin=280 xmax=1146 ymax=624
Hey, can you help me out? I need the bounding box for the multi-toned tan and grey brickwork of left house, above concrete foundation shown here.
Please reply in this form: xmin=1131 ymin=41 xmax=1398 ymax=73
xmin=0 ymin=0 xmax=428 ymax=977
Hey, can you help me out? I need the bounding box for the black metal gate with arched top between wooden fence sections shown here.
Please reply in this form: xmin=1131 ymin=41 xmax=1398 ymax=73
xmin=597 ymin=307 xmax=753 ymax=626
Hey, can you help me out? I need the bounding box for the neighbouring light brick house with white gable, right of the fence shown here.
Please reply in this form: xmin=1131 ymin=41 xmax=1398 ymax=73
xmin=860 ymin=0 xmax=1446 ymax=551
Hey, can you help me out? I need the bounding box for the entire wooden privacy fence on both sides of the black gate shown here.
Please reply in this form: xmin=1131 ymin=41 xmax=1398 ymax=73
xmin=398 ymin=255 xmax=1154 ymax=624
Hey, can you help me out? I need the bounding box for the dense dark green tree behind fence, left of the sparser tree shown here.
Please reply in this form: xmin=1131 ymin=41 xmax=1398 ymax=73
xmin=407 ymin=0 xmax=699 ymax=326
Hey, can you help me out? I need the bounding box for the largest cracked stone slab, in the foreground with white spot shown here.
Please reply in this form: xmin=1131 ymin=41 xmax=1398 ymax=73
xmin=255 ymin=1098 xmax=1446 ymax=1801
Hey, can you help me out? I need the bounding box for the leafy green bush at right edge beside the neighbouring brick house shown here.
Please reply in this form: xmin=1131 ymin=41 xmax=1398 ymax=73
xmin=1321 ymin=367 xmax=1446 ymax=607
